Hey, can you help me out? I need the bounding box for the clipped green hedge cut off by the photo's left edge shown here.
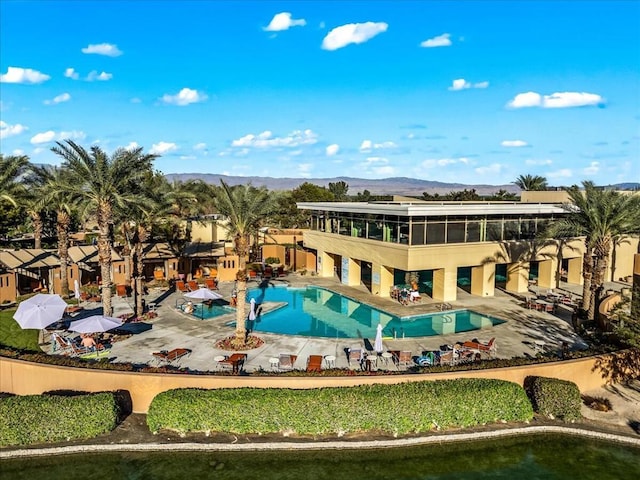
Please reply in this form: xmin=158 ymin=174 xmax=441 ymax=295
xmin=0 ymin=392 xmax=118 ymax=447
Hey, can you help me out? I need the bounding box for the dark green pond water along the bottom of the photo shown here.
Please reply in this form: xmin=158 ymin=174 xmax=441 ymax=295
xmin=0 ymin=435 xmax=640 ymax=480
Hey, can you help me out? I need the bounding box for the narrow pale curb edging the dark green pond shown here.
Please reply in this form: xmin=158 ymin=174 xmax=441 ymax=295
xmin=0 ymin=425 xmax=640 ymax=460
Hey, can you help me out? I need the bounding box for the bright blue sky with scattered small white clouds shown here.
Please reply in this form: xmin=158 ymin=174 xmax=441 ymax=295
xmin=0 ymin=0 xmax=640 ymax=185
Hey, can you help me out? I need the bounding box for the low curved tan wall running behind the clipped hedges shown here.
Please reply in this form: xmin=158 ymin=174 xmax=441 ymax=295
xmin=0 ymin=355 xmax=609 ymax=413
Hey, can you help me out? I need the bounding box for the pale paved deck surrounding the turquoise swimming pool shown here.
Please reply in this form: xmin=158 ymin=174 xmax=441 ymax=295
xmin=43 ymin=274 xmax=624 ymax=372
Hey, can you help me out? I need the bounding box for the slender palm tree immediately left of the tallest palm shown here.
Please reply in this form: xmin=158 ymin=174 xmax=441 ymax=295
xmin=34 ymin=167 xmax=74 ymax=297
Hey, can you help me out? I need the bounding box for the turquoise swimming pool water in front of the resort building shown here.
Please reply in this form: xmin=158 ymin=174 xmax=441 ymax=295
xmin=208 ymin=286 xmax=504 ymax=338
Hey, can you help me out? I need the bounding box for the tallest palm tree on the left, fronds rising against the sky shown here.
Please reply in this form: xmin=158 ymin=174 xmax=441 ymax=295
xmin=51 ymin=140 xmax=156 ymax=316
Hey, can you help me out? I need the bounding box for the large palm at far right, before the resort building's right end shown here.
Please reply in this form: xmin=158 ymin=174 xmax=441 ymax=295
xmin=549 ymin=181 xmax=640 ymax=320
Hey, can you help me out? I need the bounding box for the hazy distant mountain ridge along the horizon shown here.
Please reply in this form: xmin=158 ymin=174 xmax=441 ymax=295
xmin=165 ymin=173 xmax=640 ymax=196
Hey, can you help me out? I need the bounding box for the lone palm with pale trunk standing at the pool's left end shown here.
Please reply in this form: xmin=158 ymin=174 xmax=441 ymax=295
xmin=215 ymin=180 xmax=275 ymax=347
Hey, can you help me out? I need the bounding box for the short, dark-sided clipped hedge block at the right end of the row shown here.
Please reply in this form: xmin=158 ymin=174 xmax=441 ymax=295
xmin=524 ymin=376 xmax=582 ymax=422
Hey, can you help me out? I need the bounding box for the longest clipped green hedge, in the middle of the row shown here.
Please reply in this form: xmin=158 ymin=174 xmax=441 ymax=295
xmin=147 ymin=379 xmax=533 ymax=435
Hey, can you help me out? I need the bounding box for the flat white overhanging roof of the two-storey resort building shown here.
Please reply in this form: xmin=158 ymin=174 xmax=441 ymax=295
xmin=296 ymin=202 xmax=567 ymax=217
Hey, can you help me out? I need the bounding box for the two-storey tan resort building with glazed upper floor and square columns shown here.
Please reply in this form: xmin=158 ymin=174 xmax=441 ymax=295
xmin=297 ymin=200 xmax=638 ymax=302
